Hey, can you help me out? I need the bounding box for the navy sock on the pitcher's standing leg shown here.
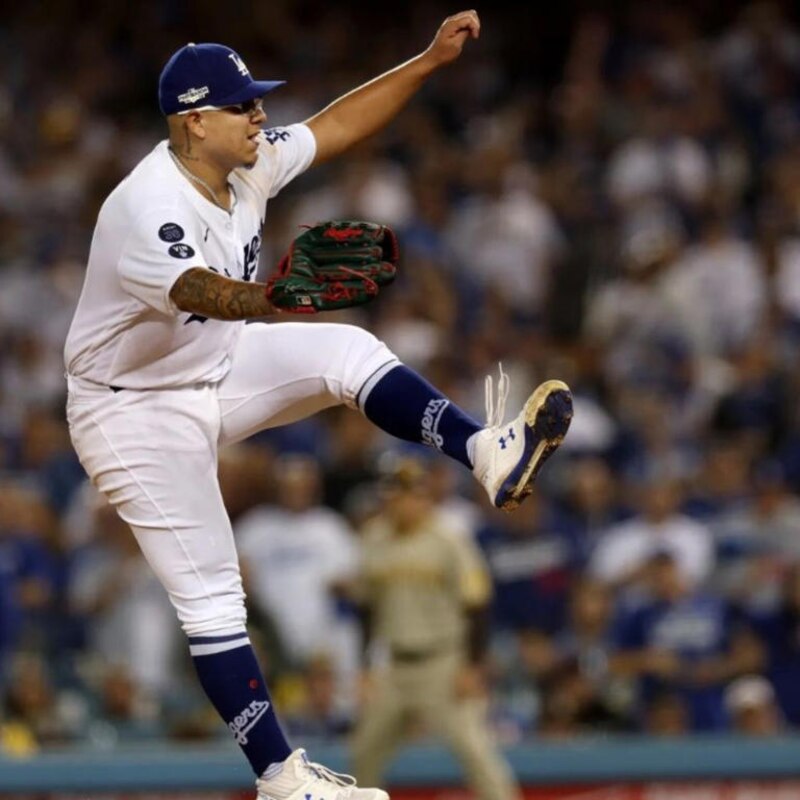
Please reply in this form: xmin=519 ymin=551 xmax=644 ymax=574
xmin=189 ymin=631 xmax=292 ymax=777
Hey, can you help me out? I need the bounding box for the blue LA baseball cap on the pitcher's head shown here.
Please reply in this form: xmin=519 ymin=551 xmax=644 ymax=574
xmin=158 ymin=42 xmax=285 ymax=116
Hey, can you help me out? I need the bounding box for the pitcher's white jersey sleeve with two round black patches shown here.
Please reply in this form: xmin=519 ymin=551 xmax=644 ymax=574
xmin=117 ymin=207 xmax=208 ymax=315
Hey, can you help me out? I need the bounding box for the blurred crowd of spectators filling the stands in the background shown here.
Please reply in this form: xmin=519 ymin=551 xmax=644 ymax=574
xmin=0 ymin=0 xmax=800 ymax=752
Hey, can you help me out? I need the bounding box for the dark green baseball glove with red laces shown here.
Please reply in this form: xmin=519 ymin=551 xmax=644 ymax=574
xmin=266 ymin=225 xmax=399 ymax=314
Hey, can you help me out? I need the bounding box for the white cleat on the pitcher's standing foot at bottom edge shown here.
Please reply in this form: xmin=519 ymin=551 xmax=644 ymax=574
xmin=256 ymin=748 xmax=389 ymax=800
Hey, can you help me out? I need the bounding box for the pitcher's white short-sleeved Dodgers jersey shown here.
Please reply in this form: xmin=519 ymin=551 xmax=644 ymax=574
xmin=65 ymin=124 xmax=316 ymax=389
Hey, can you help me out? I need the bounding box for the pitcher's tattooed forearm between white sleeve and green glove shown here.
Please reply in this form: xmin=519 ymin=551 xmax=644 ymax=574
xmin=169 ymin=267 xmax=275 ymax=320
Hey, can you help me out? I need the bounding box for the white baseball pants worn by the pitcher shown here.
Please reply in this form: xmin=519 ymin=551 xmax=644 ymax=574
xmin=67 ymin=323 xmax=399 ymax=636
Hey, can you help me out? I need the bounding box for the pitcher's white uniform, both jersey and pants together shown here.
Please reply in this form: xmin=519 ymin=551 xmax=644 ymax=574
xmin=65 ymin=125 xmax=398 ymax=635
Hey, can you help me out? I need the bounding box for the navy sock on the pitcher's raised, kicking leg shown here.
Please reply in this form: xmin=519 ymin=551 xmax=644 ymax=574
xmin=360 ymin=364 xmax=483 ymax=469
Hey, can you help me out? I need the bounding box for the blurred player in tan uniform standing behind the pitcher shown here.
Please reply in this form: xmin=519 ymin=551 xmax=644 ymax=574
xmin=353 ymin=458 xmax=519 ymax=800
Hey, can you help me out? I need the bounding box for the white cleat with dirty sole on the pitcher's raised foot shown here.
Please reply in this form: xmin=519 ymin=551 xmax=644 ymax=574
xmin=472 ymin=367 xmax=572 ymax=511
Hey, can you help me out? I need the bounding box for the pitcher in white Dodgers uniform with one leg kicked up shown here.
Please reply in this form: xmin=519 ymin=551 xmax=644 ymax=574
xmin=65 ymin=11 xmax=571 ymax=800
